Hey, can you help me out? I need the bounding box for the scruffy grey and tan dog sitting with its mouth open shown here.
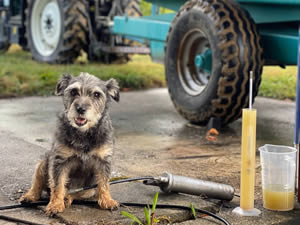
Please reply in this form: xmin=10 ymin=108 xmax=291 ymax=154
xmin=20 ymin=73 xmax=119 ymax=215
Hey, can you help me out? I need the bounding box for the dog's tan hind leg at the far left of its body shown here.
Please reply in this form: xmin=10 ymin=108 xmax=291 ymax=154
xmin=19 ymin=160 xmax=47 ymax=203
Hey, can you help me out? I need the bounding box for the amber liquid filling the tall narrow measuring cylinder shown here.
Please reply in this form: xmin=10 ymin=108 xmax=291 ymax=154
xmin=240 ymin=109 xmax=256 ymax=210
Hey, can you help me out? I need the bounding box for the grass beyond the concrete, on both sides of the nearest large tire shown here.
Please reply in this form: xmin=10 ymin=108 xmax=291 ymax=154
xmin=0 ymin=46 xmax=297 ymax=100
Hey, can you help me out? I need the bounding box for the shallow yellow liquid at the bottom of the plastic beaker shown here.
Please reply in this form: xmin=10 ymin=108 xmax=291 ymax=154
xmin=263 ymin=186 xmax=295 ymax=211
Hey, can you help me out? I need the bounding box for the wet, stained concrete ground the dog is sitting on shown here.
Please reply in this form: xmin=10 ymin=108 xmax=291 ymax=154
xmin=0 ymin=89 xmax=300 ymax=225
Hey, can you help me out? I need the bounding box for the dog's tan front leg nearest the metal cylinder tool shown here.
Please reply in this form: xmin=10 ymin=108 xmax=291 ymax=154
xmin=98 ymin=179 xmax=119 ymax=209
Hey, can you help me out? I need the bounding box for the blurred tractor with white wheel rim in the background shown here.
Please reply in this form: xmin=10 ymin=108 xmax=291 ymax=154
xmin=0 ymin=0 xmax=147 ymax=63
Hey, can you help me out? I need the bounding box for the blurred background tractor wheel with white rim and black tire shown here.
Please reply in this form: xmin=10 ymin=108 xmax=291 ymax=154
xmin=26 ymin=0 xmax=88 ymax=63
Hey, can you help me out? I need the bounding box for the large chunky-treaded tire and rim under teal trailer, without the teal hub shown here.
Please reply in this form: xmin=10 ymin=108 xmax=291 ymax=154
xmin=165 ymin=0 xmax=263 ymax=125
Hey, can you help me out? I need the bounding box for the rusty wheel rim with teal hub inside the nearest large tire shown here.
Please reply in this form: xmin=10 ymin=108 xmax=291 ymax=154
xmin=177 ymin=29 xmax=212 ymax=96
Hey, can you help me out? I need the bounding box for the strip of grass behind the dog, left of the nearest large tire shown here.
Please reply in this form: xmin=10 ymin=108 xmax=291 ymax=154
xmin=0 ymin=46 xmax=165 ymax=97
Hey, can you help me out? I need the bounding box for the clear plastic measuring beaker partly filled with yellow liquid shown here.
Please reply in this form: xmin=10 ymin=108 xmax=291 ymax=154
xmin=259 ymin=144 xmax=297 ymax=211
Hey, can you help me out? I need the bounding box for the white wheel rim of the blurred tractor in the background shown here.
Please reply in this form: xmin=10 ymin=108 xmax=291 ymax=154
xmin=31 ymin=0 xmax=61 ymax=56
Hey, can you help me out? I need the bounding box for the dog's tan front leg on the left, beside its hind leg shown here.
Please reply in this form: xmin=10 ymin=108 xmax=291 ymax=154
xmin=46 ymin=166 xmax=69 ymax=216
